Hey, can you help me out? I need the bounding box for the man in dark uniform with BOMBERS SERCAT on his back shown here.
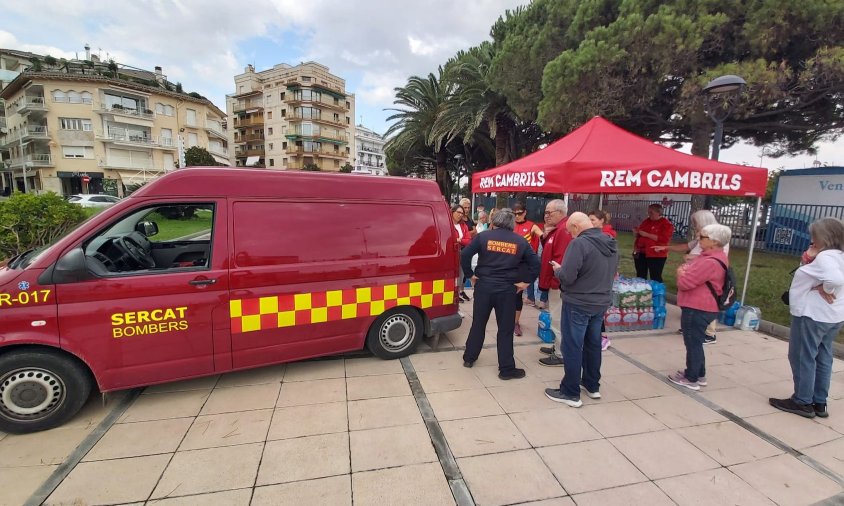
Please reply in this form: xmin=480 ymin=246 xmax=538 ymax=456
xmin=461 ymin=209 xmax=539 ymax=380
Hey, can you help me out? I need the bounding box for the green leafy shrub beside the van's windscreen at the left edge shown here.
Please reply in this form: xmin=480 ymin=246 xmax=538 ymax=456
xmin=0 ymin=192 xmax=86 ymax=258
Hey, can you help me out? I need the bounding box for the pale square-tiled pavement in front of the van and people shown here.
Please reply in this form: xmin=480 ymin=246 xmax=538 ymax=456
xmin=0 ymin=298 xmax=844 ymax=506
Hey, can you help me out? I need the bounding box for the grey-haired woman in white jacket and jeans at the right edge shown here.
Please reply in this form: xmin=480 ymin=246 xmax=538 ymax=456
xmin=768 ymin=218 xmax=844 ymax=418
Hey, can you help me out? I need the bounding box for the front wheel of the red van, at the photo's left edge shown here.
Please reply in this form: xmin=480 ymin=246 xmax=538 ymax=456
xmin=0 ymin=349 xmax=92 ymax=434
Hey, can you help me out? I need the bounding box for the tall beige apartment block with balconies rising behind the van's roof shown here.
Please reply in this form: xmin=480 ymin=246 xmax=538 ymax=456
xmin=226 ymin=62 xmax=355 ymax=171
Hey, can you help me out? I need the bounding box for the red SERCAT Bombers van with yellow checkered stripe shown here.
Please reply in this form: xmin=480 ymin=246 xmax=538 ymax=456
xmin=0 ymin=168 xmax=461 ymax=433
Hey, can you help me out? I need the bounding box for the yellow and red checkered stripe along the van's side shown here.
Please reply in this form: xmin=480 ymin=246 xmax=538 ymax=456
xmin=229 ymin=279 xmax=455 ymax=334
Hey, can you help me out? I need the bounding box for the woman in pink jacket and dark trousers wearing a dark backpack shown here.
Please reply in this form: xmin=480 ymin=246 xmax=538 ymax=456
xmin=668 ymin=224 xmax=732 ymax=390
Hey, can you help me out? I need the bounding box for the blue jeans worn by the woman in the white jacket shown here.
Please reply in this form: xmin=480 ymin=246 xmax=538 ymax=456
xmin=788 ymin=316 xmax=844 ymax=404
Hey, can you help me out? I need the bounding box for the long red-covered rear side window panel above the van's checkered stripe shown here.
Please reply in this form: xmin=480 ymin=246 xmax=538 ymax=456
xmin=233 ymin=202 xmax=439 ymax=267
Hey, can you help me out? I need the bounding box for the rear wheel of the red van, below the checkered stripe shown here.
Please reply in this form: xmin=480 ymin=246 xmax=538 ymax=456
xmin=366 ymin=309 xmax=424 ymax=359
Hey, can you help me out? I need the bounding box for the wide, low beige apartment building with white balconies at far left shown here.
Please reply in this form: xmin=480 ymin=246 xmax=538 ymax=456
xmin=0 ymin=48 xmax=230 ymax=195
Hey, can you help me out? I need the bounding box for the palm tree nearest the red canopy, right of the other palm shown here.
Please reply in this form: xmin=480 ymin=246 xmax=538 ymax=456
xmin=431 ymin=42 xmax=519 ymax=202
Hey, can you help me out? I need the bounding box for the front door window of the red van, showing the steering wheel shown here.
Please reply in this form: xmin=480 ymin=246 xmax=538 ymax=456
xmin=83 ymin=203 xmax=214 ymax=276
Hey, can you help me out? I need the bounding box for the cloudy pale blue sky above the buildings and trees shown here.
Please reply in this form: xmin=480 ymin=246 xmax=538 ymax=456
xmin=0 ymin=0 xmax=844 ymax=168
